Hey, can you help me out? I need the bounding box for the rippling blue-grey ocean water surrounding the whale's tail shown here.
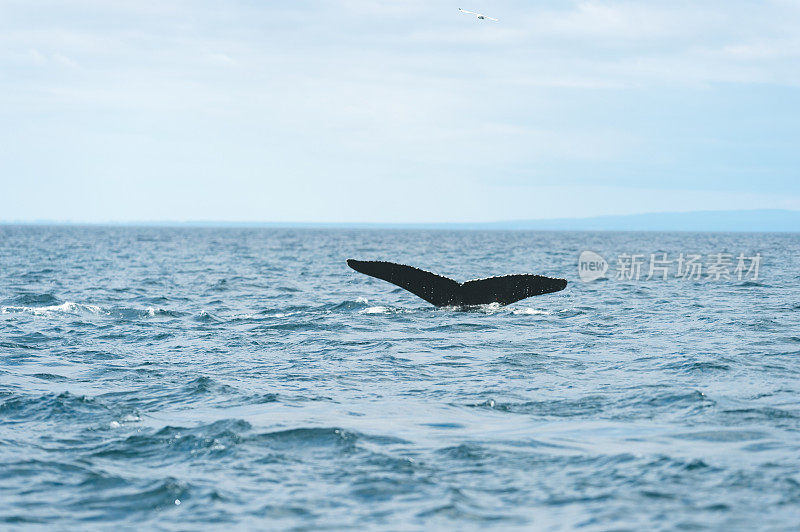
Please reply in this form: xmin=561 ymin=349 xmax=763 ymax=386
xmin=0 ymin=226 xmax=800 ymax=530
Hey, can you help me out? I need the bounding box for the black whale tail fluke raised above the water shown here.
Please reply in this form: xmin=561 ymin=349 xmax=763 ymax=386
xmin=347 ymin=259 xmax=567 ymax=307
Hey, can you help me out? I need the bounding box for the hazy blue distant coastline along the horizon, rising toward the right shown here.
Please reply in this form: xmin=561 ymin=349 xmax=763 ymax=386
xmin=6 ymin=209 xmax=800 ymax=233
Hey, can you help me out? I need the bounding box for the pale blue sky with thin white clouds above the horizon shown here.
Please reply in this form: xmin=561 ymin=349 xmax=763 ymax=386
xmin=0 ymin=0 xmax=800 ymax=222
